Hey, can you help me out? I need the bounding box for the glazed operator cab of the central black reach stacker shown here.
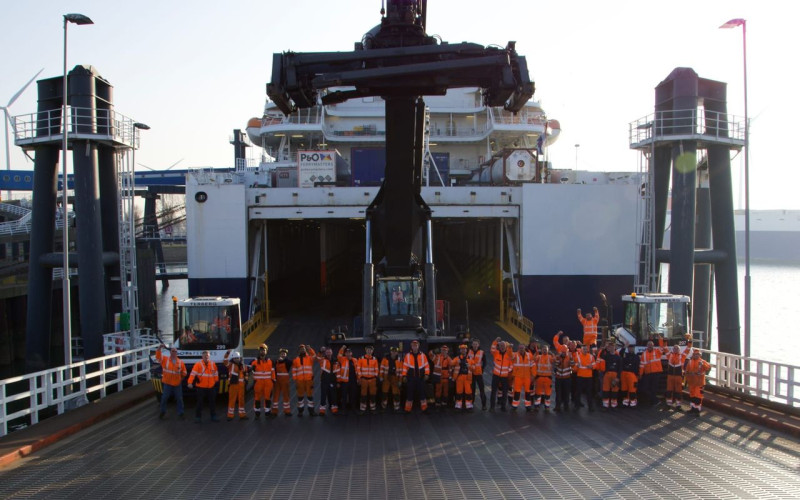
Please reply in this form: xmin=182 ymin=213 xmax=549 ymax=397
xmin=375 ymin=276 xmax=423 ymax=330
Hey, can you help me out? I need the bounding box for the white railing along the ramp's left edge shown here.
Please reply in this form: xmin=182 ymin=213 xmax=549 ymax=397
xmin=0 ymin=335 xmax=157 ymax=436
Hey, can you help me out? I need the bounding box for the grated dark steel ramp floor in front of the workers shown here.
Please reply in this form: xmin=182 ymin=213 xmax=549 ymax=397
xmin=0 ymin=318 xmax=800 ymax=500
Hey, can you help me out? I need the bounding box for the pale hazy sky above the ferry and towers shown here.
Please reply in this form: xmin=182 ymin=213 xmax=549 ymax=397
xmin=0 ymin=0 xmax=800 ymax=209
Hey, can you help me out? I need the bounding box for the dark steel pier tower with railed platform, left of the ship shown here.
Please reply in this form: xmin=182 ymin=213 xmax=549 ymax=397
xmin=15 ymin=65 xmax=137 ymax=371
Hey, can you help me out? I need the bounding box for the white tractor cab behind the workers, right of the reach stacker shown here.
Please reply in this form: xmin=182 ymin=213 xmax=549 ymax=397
xmin=615 ymin=293 xmax=691 ymax=351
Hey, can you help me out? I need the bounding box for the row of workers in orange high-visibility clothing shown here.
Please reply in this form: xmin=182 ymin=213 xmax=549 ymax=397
xmin=156 ymin=308 xmax=710 ymax=422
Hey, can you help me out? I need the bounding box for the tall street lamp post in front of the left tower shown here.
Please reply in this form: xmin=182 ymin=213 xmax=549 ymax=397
xmin=61 ymin=10 xmax=94 ymax=365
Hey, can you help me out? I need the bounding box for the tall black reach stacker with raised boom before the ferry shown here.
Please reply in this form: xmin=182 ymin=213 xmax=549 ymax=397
xmin=267 ymin=0 xmax=534 ymax=352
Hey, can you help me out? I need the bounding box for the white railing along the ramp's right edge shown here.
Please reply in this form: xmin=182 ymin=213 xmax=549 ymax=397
xmin=701 ymin=349 xmax=800 ymax=408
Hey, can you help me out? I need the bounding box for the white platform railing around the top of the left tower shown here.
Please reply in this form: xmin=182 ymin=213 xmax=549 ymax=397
xmin=12 ymin=106 xmax=136 ymax=147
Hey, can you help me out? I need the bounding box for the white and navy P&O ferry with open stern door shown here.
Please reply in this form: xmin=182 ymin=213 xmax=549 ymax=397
xmin=186 ymin=88 xmax=641 ymax=336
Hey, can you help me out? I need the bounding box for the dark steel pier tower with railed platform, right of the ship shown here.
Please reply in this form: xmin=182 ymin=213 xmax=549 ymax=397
xmin=629 ymin=68 xmax=745 ymax=354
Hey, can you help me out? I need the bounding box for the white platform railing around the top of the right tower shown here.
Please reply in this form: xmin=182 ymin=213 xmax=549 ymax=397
xmin=628 ymin=108 xmax=744 ymax=149
